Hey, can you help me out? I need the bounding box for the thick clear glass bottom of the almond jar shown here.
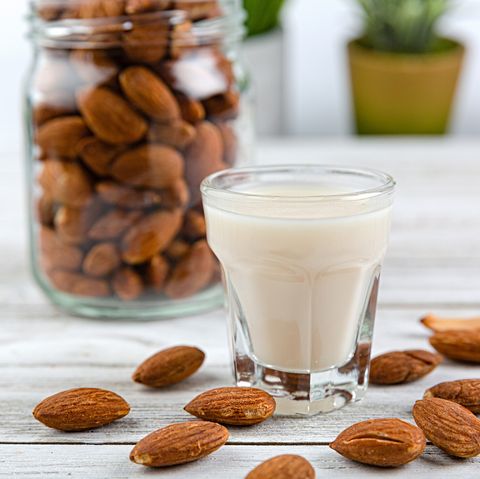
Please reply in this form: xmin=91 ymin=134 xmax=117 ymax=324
xmin=35 ymin=275 xmax=224 ymax=320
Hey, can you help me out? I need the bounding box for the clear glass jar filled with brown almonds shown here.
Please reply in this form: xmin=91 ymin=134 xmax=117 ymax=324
xmin=26 ymin=0 xmax=252 ymax=318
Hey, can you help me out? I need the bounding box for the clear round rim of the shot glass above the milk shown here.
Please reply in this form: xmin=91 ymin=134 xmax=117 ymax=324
xmin=200 ymin=163 xmax=396 ymax=202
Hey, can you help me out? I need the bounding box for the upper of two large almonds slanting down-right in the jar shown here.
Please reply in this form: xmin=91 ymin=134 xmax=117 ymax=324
xmin=119 ymin=66 xmax=180 ymax=122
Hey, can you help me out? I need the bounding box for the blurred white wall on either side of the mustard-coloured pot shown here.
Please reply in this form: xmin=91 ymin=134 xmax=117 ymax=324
xmin=284 ymin=0 xmax=480 ymax=134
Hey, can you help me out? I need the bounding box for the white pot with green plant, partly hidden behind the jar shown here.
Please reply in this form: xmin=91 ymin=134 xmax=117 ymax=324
xmin=243 ymin=0 xmax=286 ymax=136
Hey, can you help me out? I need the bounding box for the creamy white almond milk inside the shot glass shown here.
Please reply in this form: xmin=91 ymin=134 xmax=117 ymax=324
xmin=205 ymin=183 xmax=391 ymax=372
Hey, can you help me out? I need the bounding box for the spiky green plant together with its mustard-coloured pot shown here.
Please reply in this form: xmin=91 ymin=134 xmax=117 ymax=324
xmin=348 ymin=0 xmax=464 ymax=134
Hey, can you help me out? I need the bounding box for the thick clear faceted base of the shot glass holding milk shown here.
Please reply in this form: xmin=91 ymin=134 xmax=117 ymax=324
xmin=234 ymin=343 xmax=370 ymax=416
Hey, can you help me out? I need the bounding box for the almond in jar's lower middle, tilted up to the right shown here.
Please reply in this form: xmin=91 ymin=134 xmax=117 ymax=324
xmin=122 ymin=211 xmax=182 ymax=264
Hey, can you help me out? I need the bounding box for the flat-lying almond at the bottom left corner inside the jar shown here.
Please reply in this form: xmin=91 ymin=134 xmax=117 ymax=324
xmin=48 ymin=270 xmax=112 ymax=298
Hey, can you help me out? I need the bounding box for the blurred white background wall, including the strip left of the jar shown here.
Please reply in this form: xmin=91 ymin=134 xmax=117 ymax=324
xmin=0 ymin=0 xmax=480 ymax=152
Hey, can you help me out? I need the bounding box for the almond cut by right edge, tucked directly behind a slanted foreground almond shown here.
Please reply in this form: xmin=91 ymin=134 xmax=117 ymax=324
xmin=423 ymin=379 xmax=480 ymax=414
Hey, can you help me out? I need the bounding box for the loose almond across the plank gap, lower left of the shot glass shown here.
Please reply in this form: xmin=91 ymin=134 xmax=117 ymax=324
xmin=130 ymin=421 xmax=229 ymax=467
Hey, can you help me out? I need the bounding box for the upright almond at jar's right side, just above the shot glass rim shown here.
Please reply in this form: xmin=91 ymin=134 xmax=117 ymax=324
xmin=185 ymin=121 xmax=225 ymax=204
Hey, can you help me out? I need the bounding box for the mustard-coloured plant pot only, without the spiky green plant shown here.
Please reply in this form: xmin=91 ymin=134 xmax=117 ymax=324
xmin=348 ymin=39 xmax=465 ymax=135
